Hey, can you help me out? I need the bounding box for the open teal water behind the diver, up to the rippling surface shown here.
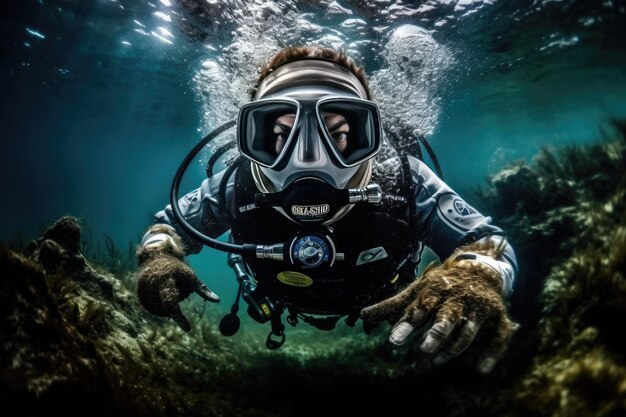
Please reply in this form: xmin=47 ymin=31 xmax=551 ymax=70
xmin=0 ymin=0 xmax=626 ymax=307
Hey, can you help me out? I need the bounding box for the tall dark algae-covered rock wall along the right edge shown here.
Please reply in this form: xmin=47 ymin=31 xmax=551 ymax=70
xmin=472 ymin=122 xmax=626 ymax=417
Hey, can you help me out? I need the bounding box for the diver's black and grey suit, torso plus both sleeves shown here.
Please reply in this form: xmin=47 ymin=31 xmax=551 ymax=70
xmin=149 ymin=153 xmax=516 ymax=315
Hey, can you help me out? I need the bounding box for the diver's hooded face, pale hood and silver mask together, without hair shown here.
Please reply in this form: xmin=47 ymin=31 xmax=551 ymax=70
xmin=237 ymin=57 xmax=382 ymax=193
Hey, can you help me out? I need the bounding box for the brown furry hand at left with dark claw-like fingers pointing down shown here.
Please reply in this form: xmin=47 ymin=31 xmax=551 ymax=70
xmin=137 ymin=225 xmax=220 ymax=332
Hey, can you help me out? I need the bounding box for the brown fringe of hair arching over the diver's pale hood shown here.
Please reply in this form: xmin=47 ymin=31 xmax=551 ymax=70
xmin=250 ymin=46 xmax=372 ymax=100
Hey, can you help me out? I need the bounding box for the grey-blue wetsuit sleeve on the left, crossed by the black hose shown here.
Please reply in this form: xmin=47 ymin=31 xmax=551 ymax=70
xmin=142 ymin=171 xmax=234 ymax=255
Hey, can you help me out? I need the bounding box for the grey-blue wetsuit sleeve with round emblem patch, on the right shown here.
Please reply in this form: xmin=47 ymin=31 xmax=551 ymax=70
xmin=409 ymin=158 xmax=517 ymax=295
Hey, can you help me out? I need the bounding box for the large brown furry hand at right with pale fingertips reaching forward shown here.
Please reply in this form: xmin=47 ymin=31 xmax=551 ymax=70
xmin=361 ymin=242 xmax=517 ymax=374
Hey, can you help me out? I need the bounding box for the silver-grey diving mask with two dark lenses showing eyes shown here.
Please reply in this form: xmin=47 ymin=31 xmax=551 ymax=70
xmin=238 ymin=95 xmax=381 ymax=191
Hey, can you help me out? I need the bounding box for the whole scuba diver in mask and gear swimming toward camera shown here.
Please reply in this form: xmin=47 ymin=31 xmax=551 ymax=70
xmin=137 ymin=47 xmax=517 ymax=373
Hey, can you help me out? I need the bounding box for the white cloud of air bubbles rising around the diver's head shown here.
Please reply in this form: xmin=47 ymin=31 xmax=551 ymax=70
xmin=193 ymin=1 xmax=453 ymax=154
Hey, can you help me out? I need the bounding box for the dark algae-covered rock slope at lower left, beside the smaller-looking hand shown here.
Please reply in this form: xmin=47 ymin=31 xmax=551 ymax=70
xmin=0 ymin=217 xmax=241 ymax=416
